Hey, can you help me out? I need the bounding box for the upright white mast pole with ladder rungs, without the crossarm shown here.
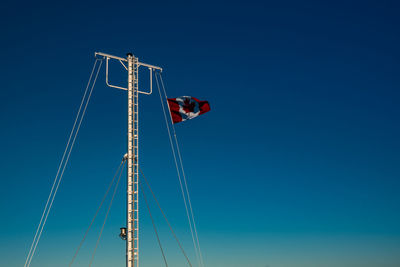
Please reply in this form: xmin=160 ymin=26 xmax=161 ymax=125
xmin=126 ymin=53 xmax=139 ymax=267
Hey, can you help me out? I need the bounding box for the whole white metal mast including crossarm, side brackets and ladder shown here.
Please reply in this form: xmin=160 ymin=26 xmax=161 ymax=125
xmin=95 ymin=52 xmax=162 ymax=267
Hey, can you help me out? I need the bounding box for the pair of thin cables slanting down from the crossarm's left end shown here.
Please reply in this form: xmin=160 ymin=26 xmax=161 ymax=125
xmin=24 ymin=59 xmax=103 ymax=267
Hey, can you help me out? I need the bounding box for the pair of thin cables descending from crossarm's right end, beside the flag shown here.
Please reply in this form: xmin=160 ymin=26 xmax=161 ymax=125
xmin=155 ymin=73 xmax=204 ymax=266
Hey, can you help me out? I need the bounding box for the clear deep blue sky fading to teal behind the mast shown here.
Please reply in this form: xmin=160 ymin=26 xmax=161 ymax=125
xmin=0 ymin=1 xmax=400 ymax=267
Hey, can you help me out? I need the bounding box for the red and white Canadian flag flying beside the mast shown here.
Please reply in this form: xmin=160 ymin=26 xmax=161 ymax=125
xmin=168 ymin=96 xmax=210 ymax=123
